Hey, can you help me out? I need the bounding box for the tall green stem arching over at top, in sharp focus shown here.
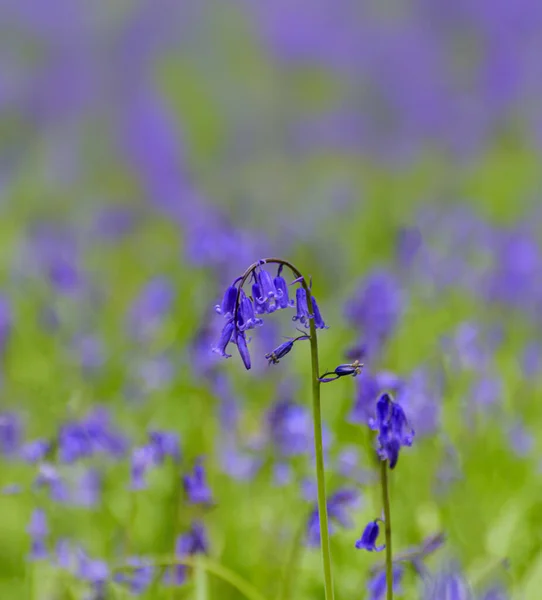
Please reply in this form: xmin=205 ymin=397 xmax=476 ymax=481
xmin=233 ymin=258 xmax=334 ymax=600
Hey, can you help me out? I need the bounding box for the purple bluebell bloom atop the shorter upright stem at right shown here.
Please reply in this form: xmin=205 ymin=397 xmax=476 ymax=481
xmin=369 ymin=394 xmax=414 ymax=469
